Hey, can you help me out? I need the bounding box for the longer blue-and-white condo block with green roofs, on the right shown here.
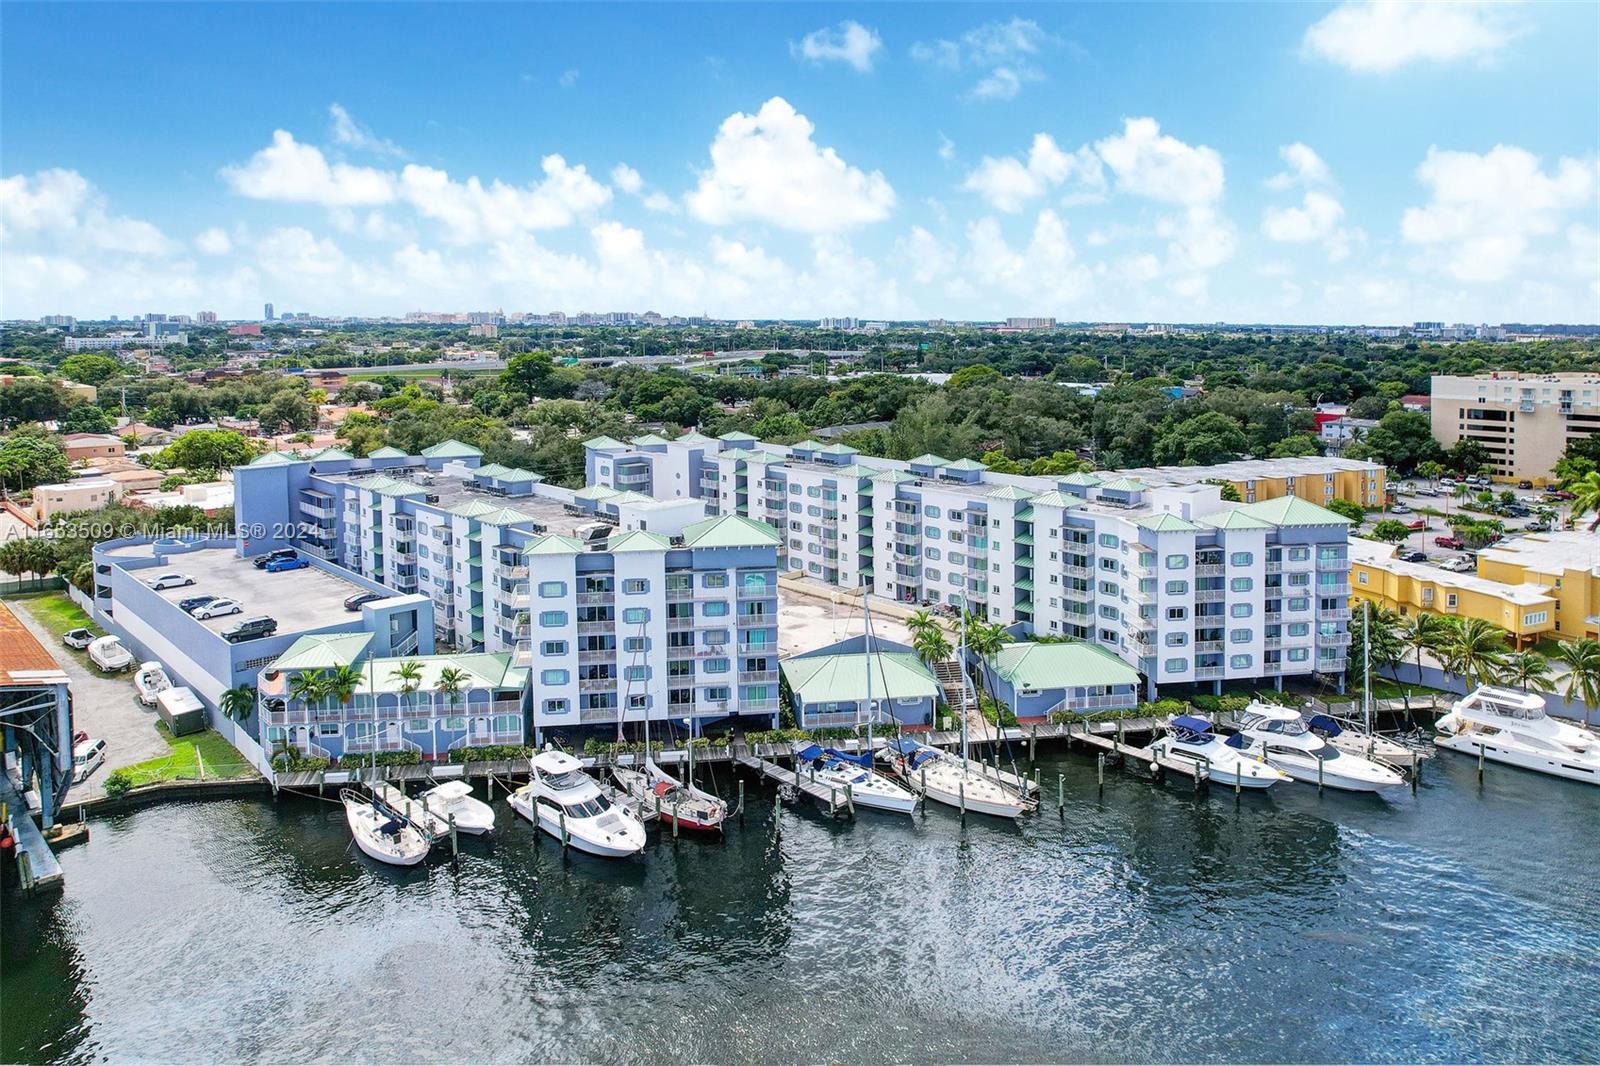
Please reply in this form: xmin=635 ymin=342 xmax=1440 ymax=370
xmin=587 ymin=434 xmax=1356 ymax=690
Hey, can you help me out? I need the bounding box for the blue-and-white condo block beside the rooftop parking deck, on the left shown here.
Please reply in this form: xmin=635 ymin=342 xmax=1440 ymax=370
xmin=235 ymin=442 xmax=779 ymax=736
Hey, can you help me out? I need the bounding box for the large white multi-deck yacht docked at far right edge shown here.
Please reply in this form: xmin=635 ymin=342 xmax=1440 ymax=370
xmin=1434 ymin=685 xmax=1600 ymax=784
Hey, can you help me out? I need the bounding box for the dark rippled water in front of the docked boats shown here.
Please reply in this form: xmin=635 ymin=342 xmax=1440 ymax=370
xmin=0 ymin=754 xmax=1600 ymax=1063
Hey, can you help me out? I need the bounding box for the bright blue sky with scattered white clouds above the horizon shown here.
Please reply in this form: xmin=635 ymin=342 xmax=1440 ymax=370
xmin=0 ymin=0 xmax=1600 ymax=322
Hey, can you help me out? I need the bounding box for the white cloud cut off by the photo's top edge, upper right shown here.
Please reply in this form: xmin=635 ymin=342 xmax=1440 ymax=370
xmin=1302 ymin=0 xmax=1523 ymax=74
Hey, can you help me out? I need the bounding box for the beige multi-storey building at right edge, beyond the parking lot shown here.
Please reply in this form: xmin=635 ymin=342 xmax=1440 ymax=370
xmin=1430 ymin=370 xmax=1600 ymax=479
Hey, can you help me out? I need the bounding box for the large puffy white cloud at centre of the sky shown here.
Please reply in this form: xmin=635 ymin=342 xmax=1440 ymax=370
xmin=685 ymin=96 xmax=894 ymax=234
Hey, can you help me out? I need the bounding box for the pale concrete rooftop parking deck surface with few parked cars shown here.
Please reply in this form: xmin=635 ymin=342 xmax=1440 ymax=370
xmin=138 ymin=547 xmax=363 ymax=634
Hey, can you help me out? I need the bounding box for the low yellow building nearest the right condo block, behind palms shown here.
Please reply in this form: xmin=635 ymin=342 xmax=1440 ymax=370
xmin=1350 ymin=536 xmax=1565 ymax=647
